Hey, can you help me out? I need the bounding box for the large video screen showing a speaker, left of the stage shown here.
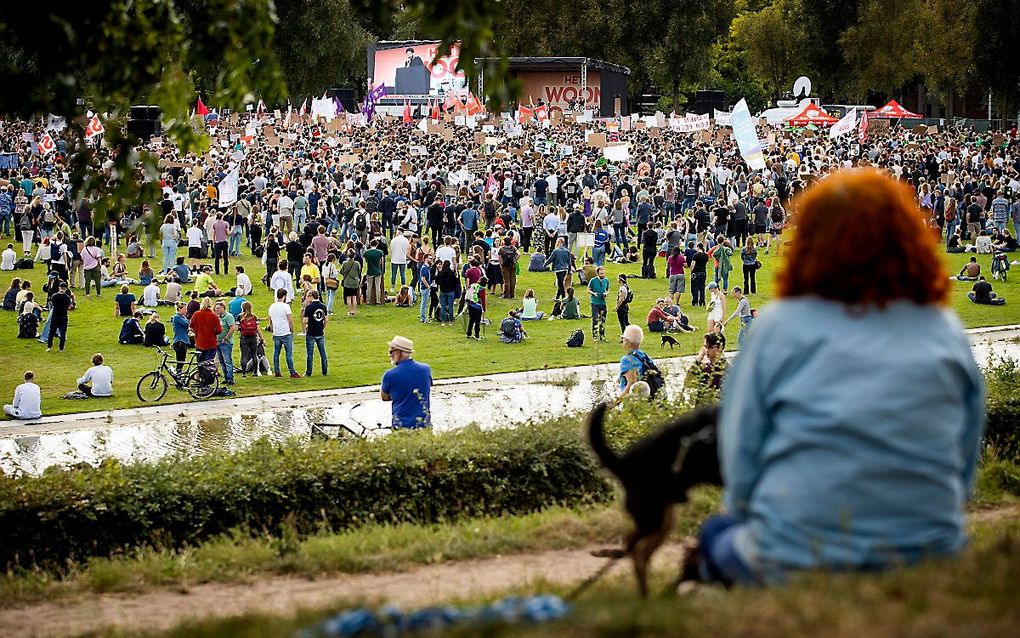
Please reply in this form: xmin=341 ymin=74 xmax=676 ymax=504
xmin=368 ymin=42 xmax=467 ymax=95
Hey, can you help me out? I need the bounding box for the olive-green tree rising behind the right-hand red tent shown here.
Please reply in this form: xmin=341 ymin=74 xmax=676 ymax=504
xmin=839 ymin=0 xmax=924 ymax=101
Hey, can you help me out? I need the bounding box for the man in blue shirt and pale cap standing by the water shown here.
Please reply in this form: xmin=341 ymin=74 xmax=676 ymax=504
xmin=379 ymin=335 xmax=432 ymax=430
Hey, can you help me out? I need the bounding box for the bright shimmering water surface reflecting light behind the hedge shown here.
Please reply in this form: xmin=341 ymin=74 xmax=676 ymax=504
xmin=0 ymin=337 xmax=1020 ymax=474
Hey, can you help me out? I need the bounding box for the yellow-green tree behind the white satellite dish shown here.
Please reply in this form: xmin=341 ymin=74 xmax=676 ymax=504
xmin=730 ymin=0 xmax=802 ymax=99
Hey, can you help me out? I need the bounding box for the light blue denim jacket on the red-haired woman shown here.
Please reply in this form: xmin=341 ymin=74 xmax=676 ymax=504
xmin=719 ymin=298 xmax=984 ymax=582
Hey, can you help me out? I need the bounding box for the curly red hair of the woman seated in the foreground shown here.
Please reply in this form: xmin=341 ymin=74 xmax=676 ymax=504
xmin=777 ymin=168 xmax=950 ymax=308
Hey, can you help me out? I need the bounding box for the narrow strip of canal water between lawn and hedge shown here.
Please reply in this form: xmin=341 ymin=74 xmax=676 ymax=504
xmin=0 ymin=328 xmax=1020 ymax=474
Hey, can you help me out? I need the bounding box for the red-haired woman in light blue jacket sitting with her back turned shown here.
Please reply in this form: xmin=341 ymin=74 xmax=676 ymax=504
xmin=697 ymin=169 xmax=984 ymax=583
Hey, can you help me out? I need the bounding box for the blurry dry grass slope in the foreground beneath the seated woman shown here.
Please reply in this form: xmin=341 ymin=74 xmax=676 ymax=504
xmin=77 ymin=518 xmax=1020 ymax=638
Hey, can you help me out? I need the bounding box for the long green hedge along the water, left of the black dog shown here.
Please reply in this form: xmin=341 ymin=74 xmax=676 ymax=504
xmin=0 ymin=418 xmax=612 ymax=568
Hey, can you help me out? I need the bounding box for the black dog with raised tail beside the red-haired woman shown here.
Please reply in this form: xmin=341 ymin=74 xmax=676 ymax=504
xmin=588 ymin=403 xmax=722 ymax=596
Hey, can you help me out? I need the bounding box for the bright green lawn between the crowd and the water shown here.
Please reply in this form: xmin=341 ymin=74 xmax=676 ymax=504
xmin=0 ymin=244 xmax=1020 ymax=414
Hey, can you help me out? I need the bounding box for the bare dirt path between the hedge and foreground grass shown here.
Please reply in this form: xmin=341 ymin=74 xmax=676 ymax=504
xmin=0 ymin=546 xmax=680 ymax=638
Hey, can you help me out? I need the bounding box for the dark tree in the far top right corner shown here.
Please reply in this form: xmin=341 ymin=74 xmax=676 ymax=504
xmin=974 ymin=0 xmax=1020 ymax=118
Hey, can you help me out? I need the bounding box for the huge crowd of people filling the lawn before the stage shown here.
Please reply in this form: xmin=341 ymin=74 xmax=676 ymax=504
xmin=0 ymin=108 xmax=1020 ymax=418
